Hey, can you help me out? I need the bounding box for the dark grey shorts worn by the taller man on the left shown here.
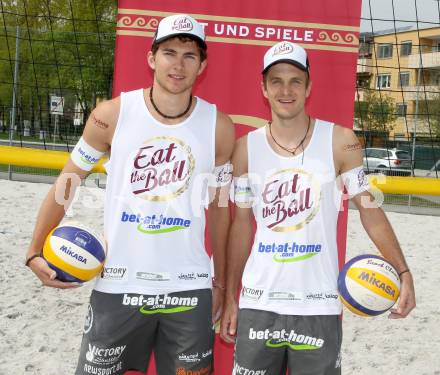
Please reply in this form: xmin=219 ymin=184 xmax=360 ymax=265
xmin=75 ymin=289 xmax=215 ymax=375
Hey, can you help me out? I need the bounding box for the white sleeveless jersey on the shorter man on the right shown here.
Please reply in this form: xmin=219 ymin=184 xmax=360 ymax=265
xmin=240 ymin=120 xmax=341 ymax=315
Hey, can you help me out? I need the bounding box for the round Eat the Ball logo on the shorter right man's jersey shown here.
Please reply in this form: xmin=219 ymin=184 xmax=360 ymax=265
xmin=261 ymin=169 xmax=321 ymax=232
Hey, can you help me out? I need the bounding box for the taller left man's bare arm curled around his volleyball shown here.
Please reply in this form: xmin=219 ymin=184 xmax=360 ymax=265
xmin=26 ymin=97 xmax=120 ymax=289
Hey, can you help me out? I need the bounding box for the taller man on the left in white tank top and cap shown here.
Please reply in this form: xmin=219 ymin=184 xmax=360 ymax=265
xmin=26 ymin=14 xmax=235 ymax=375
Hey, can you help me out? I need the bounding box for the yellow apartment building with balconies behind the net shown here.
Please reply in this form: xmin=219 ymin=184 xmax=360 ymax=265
xmin=355 ymin=27 xmax=440 ymax=140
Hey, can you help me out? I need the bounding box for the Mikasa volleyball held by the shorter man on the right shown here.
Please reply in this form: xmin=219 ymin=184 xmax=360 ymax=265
xmin=338 ymin=254 xmax=400 ymax=316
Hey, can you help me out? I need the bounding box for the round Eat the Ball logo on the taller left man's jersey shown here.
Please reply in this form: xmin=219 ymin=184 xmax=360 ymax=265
xmin=130 ymin=136 xmax=195 ymax=201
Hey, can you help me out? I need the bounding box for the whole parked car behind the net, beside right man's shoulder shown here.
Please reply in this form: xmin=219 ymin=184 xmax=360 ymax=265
xmin=363 ymin=148 xmax=411 ymax=176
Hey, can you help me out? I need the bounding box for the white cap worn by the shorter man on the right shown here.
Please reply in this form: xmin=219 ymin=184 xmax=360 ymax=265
xmin=262 ymin=41 xmax=310 ymax=74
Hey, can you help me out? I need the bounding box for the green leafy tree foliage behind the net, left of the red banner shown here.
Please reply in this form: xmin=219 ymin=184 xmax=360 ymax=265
xmin=0 ymin=0 xmax=117 ymax=138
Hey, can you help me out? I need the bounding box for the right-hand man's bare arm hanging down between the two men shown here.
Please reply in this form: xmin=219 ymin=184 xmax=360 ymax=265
xmin=220 ymin=137 xmax=253 ymax=342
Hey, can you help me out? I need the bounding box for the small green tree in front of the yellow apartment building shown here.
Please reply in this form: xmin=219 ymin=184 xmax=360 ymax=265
xmin=355 ymin=90 xmax=396 ymax=133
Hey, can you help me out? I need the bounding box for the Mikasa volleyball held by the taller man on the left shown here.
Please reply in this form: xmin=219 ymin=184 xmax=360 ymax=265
xmin=43 ymin=224 xmax=105 ymax=282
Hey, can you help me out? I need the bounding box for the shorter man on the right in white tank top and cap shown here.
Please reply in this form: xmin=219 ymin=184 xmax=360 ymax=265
xmin=221 ymin=42 xmax=415 ymax=375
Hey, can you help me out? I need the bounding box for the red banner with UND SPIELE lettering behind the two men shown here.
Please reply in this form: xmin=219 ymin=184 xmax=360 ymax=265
xmin=113 ymin=0 xmax=361 ymax=375
